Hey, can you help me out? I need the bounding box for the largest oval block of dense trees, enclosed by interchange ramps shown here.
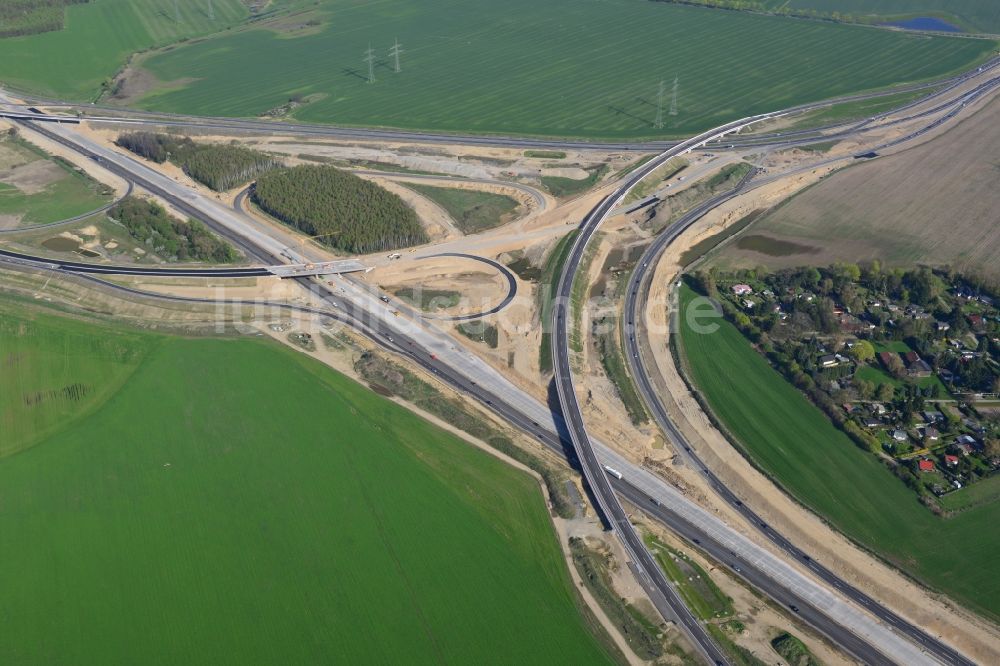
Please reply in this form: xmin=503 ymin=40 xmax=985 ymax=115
xmin=253 ymin=165 xmax=427 ymax=254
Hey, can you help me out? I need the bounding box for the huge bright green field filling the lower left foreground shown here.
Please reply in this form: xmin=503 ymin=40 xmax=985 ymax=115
xmin=0 ymin=301 xmax=612 ymax=666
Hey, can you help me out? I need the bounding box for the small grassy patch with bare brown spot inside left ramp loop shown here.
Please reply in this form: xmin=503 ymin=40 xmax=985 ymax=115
xmin=0 ymin=135 xmax=111 ymax=228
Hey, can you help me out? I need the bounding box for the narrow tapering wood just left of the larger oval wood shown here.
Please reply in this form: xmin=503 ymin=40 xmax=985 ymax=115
xmin=116 ymin=132 xmax=282 ymax=192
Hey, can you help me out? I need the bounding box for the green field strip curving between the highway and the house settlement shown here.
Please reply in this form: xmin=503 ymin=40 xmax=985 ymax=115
xmin=680 ymin=287 xmax=1000 ymax=618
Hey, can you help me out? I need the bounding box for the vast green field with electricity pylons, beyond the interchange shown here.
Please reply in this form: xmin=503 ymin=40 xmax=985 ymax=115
xmin=56 ymin=0 xmax=995 ymax=138
